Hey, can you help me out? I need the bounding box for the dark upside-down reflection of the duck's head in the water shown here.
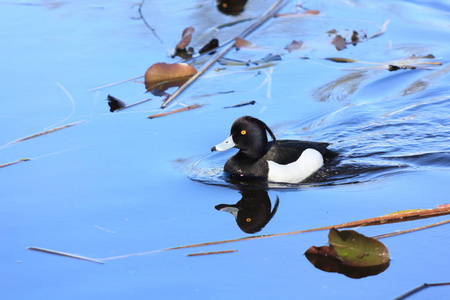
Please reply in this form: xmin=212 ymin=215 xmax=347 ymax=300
xmin=216 ymin=188 xmax=280 ymax=233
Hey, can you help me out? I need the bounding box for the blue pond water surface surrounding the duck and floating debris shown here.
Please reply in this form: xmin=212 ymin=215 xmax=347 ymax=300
xmin=0 ymin=1 xmax=450 ymax=299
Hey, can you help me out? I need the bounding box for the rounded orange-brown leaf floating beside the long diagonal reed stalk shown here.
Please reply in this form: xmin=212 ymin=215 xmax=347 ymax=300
xmin=145 ymin=63 xmax=197 ymax=92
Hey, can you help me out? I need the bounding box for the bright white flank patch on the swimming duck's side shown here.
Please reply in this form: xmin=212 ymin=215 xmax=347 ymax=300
xmin=267 ymin=148 xmax=323 ymax=183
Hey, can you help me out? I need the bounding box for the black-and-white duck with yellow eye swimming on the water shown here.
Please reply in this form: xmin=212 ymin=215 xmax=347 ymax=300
xmin=211 ymin=116 xmax=338 ymax=183
